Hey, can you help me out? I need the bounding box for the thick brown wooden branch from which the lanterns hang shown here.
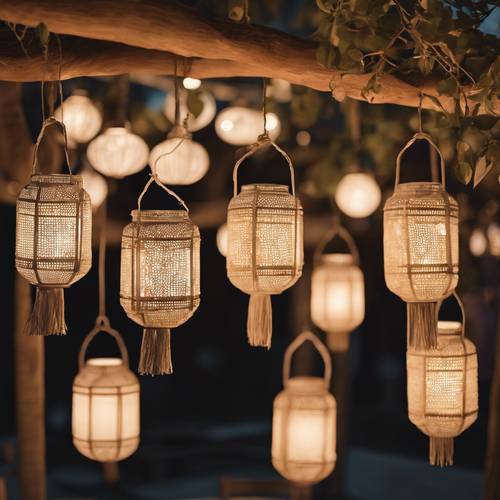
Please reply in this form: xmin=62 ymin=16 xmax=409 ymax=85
xmin=0 ymin=0 xmax=492 ymax=110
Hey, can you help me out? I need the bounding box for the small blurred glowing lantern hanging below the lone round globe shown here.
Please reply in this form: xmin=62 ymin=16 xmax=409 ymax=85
xmin=311 ymin=224 xmax=365 ymax=352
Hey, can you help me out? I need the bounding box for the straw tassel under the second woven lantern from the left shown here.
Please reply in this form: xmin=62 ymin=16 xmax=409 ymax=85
xmin=139 ymin=328 xmax=173 ymax=375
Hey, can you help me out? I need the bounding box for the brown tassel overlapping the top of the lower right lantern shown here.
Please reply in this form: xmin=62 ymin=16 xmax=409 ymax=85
xmin=407 ymin=302 xmax=437 ymax=350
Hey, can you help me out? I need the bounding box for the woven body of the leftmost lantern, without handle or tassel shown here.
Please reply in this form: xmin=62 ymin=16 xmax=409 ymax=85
xmin=16 ymin=174 xmax=92 ymax=287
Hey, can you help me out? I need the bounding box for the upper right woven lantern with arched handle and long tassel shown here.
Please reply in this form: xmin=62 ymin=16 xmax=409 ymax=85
xmin=384 ymin=133 xmax=458 ymax=349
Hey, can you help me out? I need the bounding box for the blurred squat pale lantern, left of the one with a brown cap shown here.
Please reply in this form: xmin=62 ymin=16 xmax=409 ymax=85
xmin=87 ymin=125 xmax=149 ymax=179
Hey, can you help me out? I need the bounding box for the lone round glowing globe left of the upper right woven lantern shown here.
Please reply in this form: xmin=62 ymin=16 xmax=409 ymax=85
xmin=335 ymin=172 xmax=382 ymax=217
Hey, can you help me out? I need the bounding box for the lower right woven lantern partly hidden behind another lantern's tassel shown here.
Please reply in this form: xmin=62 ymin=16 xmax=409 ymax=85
xmin=406 ymin=294 xmax=478 ymax=466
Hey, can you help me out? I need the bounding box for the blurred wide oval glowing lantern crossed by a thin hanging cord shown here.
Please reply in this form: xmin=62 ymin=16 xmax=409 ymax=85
xmin=215 ymin=106 xmax=281 ymax=146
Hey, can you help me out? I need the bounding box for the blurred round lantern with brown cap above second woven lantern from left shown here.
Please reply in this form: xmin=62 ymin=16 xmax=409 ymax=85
xmin=149 ymin=126 xmax=210 ymax=185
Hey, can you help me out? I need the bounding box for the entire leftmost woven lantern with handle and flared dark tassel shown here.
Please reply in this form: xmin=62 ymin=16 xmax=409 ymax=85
xmin=16 ymin=118 xmax=92 ymax=335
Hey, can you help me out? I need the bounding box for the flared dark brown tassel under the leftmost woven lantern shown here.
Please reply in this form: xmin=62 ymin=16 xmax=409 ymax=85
xmin=25 ymin=287 xmax=67 ymax=336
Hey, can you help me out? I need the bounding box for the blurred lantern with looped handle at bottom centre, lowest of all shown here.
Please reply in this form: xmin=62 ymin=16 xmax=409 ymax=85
xmin=272 ymin=332 xmax=337 ymax=486
